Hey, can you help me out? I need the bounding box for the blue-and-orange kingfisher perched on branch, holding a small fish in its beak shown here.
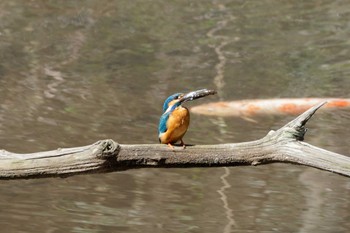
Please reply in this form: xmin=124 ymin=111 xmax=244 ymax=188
xmin=158 ymin=89 xmax=216 ymax=149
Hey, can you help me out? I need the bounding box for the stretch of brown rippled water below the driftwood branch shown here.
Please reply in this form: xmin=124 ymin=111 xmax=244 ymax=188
xmin=1 ymin=165 xmax=350 ymax=232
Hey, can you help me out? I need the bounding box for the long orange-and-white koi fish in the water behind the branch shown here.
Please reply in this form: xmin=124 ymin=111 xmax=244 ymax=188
xmin=191 ymin=98 xmax=350 ymax=118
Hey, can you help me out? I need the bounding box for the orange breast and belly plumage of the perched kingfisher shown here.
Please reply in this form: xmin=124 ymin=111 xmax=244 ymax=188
xmin=160 ymin=106 xmax=190 ymax=143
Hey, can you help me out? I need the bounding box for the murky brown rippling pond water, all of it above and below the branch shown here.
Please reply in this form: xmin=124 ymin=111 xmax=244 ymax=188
xmin=0 ymin=0 xmax=350 ymax=232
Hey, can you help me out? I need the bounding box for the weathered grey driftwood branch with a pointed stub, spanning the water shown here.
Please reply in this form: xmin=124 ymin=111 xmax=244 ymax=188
xmin=0 ymin=103 xmax=350 ymax=179
